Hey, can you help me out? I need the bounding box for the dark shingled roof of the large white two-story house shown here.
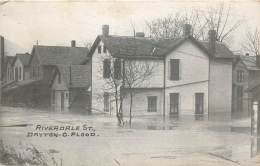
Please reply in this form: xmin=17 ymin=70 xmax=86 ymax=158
xmin=85 ymin=35 xmax=234 ymax=62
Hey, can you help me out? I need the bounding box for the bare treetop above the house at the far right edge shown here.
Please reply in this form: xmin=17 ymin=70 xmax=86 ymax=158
xmin=242 ymin=28 xmax=260 ymax=56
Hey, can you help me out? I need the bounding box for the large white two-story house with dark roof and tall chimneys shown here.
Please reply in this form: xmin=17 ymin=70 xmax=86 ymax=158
xmin=87 ymin=25 xmax=233 ymax=118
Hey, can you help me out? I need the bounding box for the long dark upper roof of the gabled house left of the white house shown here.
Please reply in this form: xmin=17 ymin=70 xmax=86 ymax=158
xmin=33 ymin=45 xmax=89 ymax=65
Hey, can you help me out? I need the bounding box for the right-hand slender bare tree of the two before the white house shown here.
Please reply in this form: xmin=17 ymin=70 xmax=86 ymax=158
xmin=124 ymin=60 xmax=154 ymax=125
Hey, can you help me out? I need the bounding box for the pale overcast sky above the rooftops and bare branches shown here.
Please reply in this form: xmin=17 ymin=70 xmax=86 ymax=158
xmin=0 ymin=0 xmax=260 ymax=56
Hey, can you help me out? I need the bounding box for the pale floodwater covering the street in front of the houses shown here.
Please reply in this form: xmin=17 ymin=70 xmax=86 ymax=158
xmin=0 ymin=107 xmax=260 ymax=166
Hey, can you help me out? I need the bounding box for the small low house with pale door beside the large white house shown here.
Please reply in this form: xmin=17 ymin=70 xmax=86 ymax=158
xmin=51 ymin=65 xmax=91 ymax=112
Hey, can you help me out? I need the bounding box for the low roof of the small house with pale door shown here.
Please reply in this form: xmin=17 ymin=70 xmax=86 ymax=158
xmin=57 ymin=65 xmax=91 ymax=88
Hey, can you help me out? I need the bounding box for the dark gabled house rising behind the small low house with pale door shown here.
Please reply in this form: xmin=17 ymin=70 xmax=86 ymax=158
xmin=26 ymin=40 xmax=88 ymax=108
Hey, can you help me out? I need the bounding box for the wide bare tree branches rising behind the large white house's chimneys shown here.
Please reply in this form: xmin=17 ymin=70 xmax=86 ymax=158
xmin=146 ymin=3 xmax=242 ymax=42
